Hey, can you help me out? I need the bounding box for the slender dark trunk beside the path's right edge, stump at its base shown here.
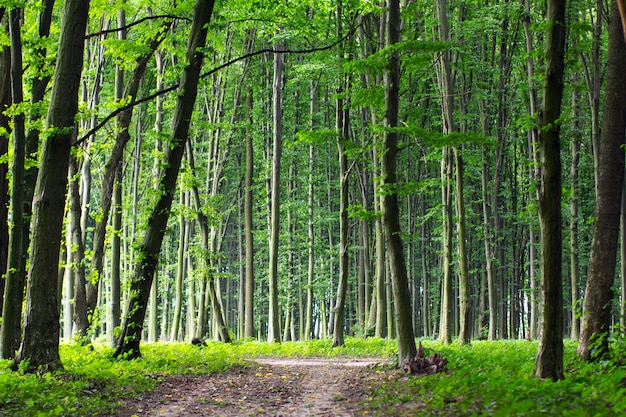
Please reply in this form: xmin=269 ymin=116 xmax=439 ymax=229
xmin=378 ymin=0 xmax=417 ymax=366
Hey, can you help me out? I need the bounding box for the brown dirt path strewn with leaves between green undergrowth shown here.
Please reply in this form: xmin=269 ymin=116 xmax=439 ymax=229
xmin=116 ymin=359 xmax=390 ymax=417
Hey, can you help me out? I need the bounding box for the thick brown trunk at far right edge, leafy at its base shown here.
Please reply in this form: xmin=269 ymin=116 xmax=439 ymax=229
xmin=578 ymin=0 xmax=626 ymax=360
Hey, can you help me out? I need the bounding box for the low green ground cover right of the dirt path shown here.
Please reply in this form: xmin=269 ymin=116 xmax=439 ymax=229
xmin=370 ymin=341 xmax=626 ymax=416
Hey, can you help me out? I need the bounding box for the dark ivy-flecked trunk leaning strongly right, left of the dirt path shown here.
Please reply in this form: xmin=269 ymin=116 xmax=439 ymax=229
xmin=114 ymin=0 xmax=214 ymax=359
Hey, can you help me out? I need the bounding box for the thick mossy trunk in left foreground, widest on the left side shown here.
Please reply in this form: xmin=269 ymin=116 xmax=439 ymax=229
xmin=18 ymin=0 xmax=89 ymax=370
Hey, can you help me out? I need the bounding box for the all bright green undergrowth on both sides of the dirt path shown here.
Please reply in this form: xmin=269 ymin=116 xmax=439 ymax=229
xmin=0 ymin=339 xmax=626 ymax=417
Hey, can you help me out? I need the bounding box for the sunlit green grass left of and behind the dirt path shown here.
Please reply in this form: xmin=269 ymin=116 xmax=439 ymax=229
xmin=0 ymin=339 xmax=395 ymax=417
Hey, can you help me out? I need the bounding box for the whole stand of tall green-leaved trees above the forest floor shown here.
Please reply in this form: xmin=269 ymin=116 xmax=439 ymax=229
xmin=0 ymin=0 xmax=626 ymax=396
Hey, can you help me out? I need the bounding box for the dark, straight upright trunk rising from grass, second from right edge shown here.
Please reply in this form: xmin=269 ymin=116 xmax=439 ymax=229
xmin=534 ymin=0 xmax=564 ymax=380
